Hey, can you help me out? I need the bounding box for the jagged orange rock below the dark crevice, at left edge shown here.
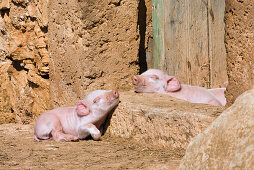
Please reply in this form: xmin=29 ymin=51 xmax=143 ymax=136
xmin=0 ymin=60 xmax=49 ymax=123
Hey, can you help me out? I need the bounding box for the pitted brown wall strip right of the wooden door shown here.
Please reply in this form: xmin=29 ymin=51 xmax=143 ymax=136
xmin=225 ymin=0 xmax=254 ymax=106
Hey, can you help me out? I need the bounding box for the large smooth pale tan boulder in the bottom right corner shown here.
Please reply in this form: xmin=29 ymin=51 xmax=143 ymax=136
xmin=179 ymin=89 xmax=254 ymax=170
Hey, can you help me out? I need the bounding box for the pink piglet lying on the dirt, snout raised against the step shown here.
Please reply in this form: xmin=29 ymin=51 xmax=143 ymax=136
xmin=34 ymin=90 xmax=119 ymax=141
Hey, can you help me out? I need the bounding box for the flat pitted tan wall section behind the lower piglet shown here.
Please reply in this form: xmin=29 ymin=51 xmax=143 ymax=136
xmin=49 ymin=0 xmax=151 ymax=107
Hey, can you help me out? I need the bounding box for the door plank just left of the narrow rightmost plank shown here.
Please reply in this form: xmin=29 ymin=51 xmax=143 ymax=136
xmin=189 ymin=0 xmax=211 ymax=88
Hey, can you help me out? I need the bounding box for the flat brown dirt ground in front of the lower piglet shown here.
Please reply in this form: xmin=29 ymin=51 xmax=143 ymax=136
xmin=0 ymin=124 xmax=181 ymax=169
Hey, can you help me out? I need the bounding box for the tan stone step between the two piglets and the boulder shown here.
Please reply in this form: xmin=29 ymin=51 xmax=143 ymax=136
xmin=106 ymin=91 xmax=224 ymax=156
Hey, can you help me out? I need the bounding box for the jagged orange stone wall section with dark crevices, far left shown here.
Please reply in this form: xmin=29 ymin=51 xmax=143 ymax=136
xmin=0 ymin=0 xmax=49 ymax=123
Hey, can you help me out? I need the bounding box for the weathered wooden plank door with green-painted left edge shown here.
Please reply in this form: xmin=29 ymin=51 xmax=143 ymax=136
xmin=153 ymin=0 xmax=227 ymax=88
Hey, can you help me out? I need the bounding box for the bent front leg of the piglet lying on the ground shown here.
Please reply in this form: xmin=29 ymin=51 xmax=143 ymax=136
xmin=78 ymin=123 xmax=101 ymax=140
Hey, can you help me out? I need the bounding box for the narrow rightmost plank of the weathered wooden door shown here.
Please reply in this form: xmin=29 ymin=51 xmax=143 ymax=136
xmin=208 ymin=0 xmax=227 ymax=88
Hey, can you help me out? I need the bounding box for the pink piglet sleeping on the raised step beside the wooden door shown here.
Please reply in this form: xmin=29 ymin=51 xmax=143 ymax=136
xmin=132 ymin=69 xmax=222 ymax=106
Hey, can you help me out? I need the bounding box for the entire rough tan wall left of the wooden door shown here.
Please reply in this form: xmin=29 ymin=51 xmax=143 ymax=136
xmin=0 ymin=0 xmax=152 ymax=123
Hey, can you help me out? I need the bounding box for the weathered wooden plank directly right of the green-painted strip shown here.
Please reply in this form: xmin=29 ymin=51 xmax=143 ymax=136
xmin=163 ymin=0 xmax=189 ymax=83
